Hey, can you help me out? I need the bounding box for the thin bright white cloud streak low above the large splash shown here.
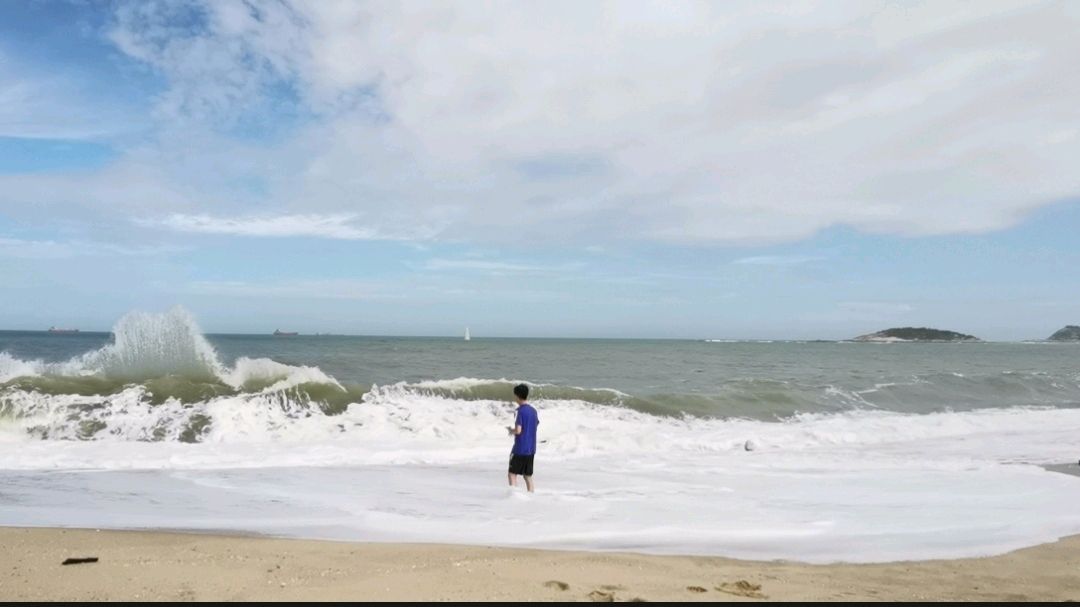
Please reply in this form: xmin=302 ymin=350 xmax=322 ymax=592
xmin=136 ymin=214 xmax=436 ymax=240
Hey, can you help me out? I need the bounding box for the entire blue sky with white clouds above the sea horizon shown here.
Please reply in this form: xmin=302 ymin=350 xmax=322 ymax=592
xmin=0 ymin=0 xmax=1080 ymax=340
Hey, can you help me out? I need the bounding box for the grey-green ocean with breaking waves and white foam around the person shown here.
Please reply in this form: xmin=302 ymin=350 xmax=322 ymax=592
xmin=0 ymin=309 xmax=1080 ymax=562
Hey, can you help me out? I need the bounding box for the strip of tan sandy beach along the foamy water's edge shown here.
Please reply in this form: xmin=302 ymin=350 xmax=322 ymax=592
xmin=0 ymin=528 xmax=1080 ymax=602
